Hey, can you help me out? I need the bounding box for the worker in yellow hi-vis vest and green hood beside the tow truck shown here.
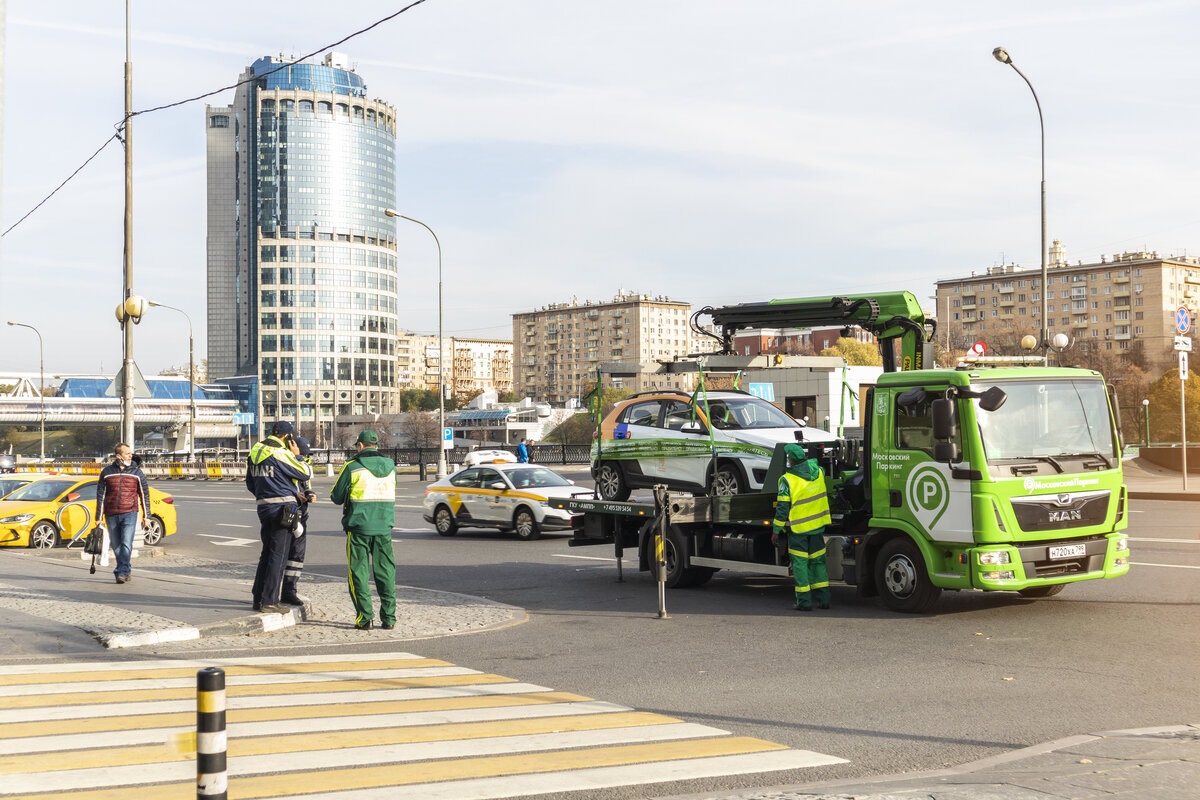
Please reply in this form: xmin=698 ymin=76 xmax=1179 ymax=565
xmin=772 ymin=445 xmax=829 ymax=612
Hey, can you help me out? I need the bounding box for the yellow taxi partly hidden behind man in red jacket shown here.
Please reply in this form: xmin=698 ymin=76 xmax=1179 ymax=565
xmin=0 ymin=474 xmax=175 ymax=549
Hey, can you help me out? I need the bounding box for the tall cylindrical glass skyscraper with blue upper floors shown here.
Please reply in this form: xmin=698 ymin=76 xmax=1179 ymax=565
xmin=205 ymin=53 xmax=397 ymax=439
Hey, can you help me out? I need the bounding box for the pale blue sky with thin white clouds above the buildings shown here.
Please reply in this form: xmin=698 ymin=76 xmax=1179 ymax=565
xmin=0 ymin=0 xmax=1200 ymax=374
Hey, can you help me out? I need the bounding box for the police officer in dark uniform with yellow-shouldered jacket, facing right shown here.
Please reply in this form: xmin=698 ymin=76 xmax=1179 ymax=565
xmin=246 ymin=421 xmax=312 ymax=614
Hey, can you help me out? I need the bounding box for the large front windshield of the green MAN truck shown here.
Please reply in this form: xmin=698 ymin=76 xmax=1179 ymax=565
xmin=974 ymin=380 xmax=1116 ymax=463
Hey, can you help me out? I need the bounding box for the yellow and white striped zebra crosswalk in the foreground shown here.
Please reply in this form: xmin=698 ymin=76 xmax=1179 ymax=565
xmin=0 ymin=652 xmax=845 ymax=800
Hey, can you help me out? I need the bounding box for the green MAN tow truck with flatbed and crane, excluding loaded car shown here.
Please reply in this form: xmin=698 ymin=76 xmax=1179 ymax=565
xmin=558 ymin=291 xmax=1129 ymax=612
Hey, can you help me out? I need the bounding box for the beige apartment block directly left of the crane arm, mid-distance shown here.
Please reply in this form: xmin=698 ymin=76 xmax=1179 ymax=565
xmin=512 ymin=291 xmax=715 ymax=403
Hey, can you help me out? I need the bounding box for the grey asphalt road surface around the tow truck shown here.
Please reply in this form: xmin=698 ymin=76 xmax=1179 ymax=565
xmin=42 ymin=470 xmax=1200 ymax=798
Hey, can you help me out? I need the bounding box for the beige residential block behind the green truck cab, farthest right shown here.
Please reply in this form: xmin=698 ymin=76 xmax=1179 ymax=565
xmin=935 ymin=241 xmax=1200 ymax=371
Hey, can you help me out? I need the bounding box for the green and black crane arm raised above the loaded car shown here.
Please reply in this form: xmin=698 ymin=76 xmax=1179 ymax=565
xmin=692 ymin=291 xmax=937 ymax=372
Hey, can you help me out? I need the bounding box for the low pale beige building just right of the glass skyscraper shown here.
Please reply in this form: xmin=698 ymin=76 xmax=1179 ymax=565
xmin=396 ymin=332 xmax=512 ymax=396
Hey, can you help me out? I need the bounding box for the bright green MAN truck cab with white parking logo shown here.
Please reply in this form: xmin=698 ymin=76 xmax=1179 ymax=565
xmin=834 ymin=367 xmax=1129 ymax=610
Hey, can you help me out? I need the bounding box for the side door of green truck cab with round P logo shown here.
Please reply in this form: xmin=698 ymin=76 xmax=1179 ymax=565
xmin=892 ymin=386 xmax=974 ymax=542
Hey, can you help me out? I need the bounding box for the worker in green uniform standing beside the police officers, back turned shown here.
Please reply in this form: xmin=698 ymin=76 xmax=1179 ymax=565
xmin=329 ymin=431 xmax=396 ymax=631
